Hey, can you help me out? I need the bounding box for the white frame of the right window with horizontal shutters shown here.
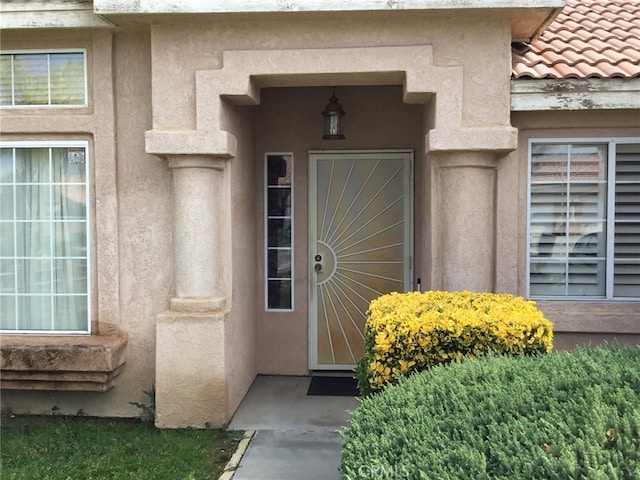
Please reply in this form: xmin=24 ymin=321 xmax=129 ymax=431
xmin=525 ymin=136 xmax=640 ymax=302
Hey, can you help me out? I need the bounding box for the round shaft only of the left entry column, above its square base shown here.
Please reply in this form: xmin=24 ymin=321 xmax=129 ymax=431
xmin=168 ymin=155 xmax=227 ymax=311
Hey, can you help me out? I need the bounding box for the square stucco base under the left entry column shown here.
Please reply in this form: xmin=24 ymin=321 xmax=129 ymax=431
xmin=155 ymin=310 xmax=229 ymax=428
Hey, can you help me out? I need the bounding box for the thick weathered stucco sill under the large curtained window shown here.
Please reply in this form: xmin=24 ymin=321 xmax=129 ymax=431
xmin=0 ymin=331 xmax=127 ymax=392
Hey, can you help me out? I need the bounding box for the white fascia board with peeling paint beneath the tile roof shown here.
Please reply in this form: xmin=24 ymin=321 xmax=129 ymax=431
xmin=511 ymin=78 xmax=640 ymax=112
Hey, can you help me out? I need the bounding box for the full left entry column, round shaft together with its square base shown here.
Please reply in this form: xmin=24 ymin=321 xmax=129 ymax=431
xmin=155 ymin=155 xmax=231 ymax=428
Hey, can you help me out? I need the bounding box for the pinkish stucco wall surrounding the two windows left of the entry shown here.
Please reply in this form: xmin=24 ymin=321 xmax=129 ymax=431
xmin=2 ymin=31 xmax=173 ymax=416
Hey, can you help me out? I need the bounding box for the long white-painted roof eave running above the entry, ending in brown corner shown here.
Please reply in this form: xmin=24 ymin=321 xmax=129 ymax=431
xmin=0 ymin=0 xmax=566 ymax=41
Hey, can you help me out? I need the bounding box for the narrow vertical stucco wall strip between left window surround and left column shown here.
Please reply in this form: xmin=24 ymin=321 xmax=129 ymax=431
xmin=112 ymin=33 xmax=173 ymax=415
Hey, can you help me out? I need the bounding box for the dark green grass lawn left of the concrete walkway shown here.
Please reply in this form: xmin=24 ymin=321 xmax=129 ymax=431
xmin=0 ymin=416 xmax=242 ymax=480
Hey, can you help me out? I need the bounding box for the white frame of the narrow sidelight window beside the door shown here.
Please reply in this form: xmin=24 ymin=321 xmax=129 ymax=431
xmin=263 ymin=152 xmax=295 ymax=312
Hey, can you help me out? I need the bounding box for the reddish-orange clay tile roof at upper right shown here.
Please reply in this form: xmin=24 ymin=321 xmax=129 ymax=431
xmin=512 ymin=0 xmax=640 ymax=79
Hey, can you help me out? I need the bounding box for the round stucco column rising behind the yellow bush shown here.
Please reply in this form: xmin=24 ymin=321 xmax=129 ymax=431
xmin=436 ymin=152 xmax=497 ymax=292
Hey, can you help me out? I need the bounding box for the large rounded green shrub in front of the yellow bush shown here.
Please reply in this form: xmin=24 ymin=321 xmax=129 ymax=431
xmin=340 ymin=346 xmax=640 ymax=480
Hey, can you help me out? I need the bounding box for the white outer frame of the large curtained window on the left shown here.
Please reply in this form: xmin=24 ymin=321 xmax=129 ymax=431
xmin=0 ymin=140 xmax=93 ymax=336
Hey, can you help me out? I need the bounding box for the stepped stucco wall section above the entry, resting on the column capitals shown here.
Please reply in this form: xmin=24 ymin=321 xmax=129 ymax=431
xmin=152 ymin=12 xmax=510 ymax=130
